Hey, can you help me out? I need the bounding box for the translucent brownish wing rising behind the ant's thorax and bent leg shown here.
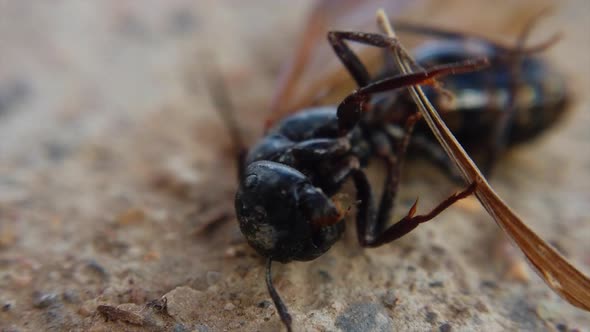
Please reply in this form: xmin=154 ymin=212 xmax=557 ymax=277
xmin=267 ymin=0 xmax=422 ymax=127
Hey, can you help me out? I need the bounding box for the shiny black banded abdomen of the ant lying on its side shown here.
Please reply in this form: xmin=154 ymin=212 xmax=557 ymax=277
xmin=415 ymin=40 xmax=568 ymax=146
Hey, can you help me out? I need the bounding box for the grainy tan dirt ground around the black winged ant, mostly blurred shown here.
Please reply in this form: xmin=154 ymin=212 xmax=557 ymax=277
xmin=0 ymin=0 xmax=590 ymax=332
